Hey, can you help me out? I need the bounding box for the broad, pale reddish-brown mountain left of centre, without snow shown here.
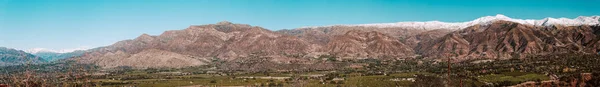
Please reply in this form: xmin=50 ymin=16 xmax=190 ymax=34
xmin=77 ymin=22 xmax=315 ymax=68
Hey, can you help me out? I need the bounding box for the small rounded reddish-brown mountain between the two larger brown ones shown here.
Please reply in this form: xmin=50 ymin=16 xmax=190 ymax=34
xmin=324 ymin=30 xmax=414 ymax=59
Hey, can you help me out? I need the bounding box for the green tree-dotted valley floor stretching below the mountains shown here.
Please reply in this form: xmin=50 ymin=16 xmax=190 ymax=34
xmin=0 ymin=55 xmax=600 ymax=87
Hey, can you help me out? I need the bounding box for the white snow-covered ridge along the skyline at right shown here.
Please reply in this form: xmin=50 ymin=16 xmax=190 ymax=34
xmin=303 ymin=14 xmax=600 ymax=30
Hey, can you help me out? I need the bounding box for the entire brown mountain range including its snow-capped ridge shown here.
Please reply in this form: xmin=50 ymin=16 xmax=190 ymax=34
xmin=56 ymin=15 xmax=600 ymax=68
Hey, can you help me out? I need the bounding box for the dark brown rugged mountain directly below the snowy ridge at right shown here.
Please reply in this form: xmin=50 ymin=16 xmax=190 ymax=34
xmin=416 ymin=20 xmax=600 ymax=61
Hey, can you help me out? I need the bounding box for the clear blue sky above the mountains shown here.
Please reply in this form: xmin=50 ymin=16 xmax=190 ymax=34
xmin=0 ymin=0 xmax=600 ymax=50
